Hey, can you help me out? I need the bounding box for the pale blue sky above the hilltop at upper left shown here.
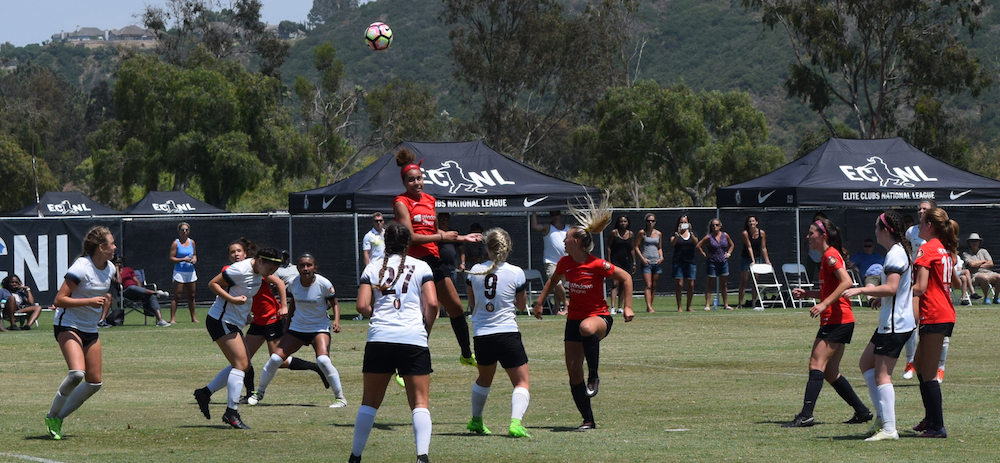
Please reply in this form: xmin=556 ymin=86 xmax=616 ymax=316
xmin=0 ymin=0 xmax=312 ymax=47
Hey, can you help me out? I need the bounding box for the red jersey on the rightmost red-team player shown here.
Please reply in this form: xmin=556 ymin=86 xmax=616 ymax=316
xmin=913 ymin=238 xmax=955 ymax=325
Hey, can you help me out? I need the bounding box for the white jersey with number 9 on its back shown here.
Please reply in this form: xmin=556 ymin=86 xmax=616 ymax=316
xmin=467 ymin=261 xmax=528 ymax=336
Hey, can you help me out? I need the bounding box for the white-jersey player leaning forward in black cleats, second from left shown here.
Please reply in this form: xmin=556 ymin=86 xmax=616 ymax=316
xmin=194 ymin=248 xmax=288 ymax=429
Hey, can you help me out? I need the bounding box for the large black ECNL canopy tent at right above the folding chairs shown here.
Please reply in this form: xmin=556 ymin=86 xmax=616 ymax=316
xmin=716 ymin=138 xmax=1000 ymax=268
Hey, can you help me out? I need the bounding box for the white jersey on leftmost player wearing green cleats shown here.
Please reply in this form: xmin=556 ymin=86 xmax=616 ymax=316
xmin=53 ymin=256 xmax=116 ymax=333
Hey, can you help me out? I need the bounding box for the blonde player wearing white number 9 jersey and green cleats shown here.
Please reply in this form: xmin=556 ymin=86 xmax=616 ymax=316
xmin=466 ymin=228 xmax=531 ymax=437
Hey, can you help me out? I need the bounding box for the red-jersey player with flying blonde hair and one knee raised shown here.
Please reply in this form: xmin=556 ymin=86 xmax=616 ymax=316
xmin=533 ymin=198 xmax=635 ymax=431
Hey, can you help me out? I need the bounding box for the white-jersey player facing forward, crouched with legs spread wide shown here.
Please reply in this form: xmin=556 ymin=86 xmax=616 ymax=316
xmin=247 ymin=254 xmax=347 ymax=408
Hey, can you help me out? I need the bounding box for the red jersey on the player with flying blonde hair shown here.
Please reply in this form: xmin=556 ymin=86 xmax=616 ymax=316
xmin=556 ymin=255 xmax=615 ymax=320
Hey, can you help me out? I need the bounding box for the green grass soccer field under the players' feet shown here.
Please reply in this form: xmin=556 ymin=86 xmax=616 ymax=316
xmin=0 ymin=297 xmax=1000 ymax=462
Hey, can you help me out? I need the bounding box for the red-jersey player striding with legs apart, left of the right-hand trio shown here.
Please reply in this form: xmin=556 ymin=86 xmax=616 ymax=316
xmin=785 ymin=217 xmax=873 ymax=428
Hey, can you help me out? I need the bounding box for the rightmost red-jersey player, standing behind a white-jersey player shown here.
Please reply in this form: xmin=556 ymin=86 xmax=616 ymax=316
xmin=913 ymin=207 xmax=959 ymax=437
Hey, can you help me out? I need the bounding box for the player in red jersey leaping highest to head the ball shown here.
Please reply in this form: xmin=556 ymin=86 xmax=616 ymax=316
xmin=392 ymin=148 xmax=482 ymax=366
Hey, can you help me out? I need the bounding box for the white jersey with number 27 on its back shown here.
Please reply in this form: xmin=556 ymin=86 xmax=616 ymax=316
xmin=361 ymin=254 xmax=434 ymax=347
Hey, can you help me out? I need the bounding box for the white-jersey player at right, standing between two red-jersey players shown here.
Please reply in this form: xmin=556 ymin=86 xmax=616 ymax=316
xmin=844 ymin=211 xmax=917 ymax=442
